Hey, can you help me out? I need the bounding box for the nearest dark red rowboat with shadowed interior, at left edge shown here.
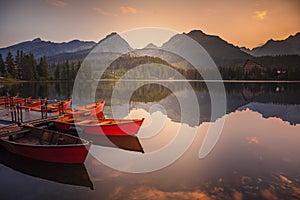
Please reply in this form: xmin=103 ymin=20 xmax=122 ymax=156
xmin=0 ymin=126 xmax=91 ymax=163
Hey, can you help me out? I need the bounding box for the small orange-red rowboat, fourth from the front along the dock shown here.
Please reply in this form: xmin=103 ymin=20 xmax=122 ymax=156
xmin=30 ymin=99 xmax=72 ymax=113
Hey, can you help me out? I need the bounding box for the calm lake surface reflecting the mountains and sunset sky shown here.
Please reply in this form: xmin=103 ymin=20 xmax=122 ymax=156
xmin=0 ymin=82 xmax=300 ymax=199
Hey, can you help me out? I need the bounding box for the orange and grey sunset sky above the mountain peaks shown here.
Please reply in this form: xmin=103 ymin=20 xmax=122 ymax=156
xmin=0 ymin=0 xmax=300 ymax=48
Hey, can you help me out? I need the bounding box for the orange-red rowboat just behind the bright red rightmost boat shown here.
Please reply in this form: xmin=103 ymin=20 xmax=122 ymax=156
xmin=64 ymin=101 xmax=105 ymax=117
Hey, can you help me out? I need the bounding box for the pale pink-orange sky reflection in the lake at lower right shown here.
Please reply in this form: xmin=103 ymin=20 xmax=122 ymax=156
xmin=82 ymin=110 xmax=300 ymax=199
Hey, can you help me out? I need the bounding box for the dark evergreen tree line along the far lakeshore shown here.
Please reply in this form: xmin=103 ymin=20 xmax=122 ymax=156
xmin=0 ymin=51 xmax=300 ymax=81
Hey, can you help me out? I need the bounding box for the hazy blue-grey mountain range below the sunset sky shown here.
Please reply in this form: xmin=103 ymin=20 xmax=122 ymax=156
xmin=0 ymin=30 xmax=300 ymax=66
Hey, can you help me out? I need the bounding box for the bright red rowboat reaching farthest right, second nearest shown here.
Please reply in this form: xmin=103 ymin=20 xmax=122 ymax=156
xmin=53 ymin=116 xmax=144 ymax=136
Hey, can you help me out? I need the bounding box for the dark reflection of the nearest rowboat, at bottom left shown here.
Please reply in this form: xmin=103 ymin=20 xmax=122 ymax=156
xmin=0 ymin=147 xmax=93 ymax=190
